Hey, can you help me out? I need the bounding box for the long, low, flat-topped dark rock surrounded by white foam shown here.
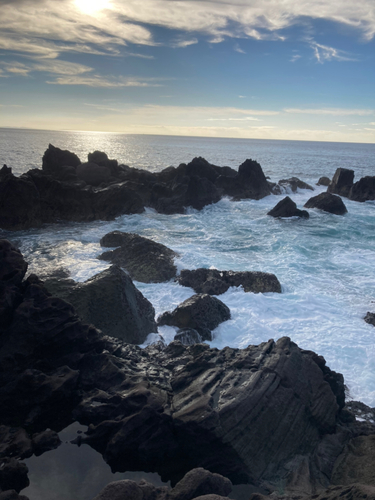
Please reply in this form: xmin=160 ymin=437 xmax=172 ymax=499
xmin=177 ymin=268 xmax=281 ymax=295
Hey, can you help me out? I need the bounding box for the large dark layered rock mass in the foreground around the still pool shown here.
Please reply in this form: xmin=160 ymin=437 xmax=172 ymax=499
xmin=0 ymin=240 xmax=375 ymax=500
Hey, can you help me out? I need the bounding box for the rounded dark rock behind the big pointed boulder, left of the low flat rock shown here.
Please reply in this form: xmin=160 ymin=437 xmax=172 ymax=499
xmin=99 ymin=231 xmax=177 ymax=283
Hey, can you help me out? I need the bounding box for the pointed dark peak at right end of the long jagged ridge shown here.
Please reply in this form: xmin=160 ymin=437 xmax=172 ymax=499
xmin=216 ymin=159 xmax=271 ymax=200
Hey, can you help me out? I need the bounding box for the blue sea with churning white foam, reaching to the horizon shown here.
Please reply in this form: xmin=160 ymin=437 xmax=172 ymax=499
xmin=0 ymin=129 xmax=375 ymax=499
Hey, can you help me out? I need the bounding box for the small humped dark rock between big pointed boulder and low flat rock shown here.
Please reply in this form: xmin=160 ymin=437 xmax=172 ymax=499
xmin=158 ymin=294 xmax=230 ymax=340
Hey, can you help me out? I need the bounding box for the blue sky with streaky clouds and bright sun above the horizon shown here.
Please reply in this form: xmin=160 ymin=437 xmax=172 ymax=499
xmin=0 ymin=0 xmax=375 ymax=143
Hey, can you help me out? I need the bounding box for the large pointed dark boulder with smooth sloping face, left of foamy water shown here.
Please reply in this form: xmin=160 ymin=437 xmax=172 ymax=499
xmin=45 ymin=266 xmax=157 ymax=344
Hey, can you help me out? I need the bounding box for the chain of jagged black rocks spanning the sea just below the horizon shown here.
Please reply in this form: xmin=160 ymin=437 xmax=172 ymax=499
xmin=0 ymin=144 xmax=375 ymax=230
